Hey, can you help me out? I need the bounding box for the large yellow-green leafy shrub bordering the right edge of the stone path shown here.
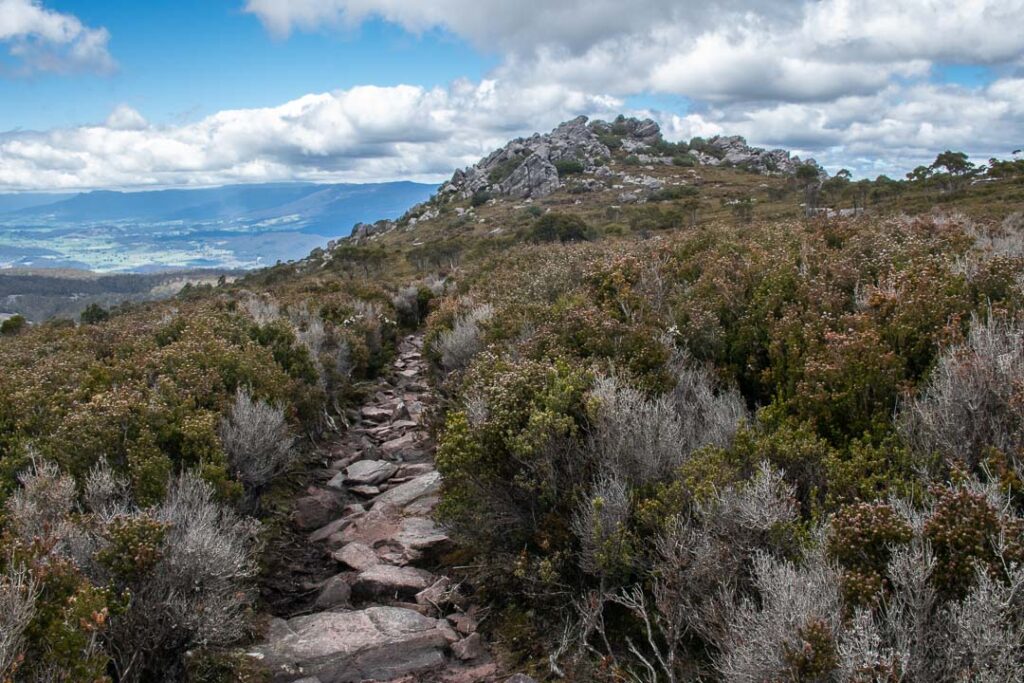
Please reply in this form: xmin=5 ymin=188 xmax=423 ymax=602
xmin=436 ymin=355 xmax=595 ymax=565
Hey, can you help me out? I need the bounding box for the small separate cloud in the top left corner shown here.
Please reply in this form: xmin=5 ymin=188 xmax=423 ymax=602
xmin=0 ymin=0 xmax=116 ymax=75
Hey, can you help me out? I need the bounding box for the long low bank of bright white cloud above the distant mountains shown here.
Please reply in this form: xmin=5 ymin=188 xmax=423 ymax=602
xmin=0 ymin=81 xmax=623 ymax=191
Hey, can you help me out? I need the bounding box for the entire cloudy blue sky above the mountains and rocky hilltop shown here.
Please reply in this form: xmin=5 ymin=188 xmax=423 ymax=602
xmin=0 ymin=0 xmax=1024 ymax=193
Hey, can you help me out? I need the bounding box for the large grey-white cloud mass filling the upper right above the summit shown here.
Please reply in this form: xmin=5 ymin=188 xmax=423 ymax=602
xmin=234 ymin=0 xmax=1024 ymax=179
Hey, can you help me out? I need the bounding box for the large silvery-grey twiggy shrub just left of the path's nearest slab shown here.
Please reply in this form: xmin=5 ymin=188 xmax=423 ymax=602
xmin=97 ymin=474 xmax=257 ymax=681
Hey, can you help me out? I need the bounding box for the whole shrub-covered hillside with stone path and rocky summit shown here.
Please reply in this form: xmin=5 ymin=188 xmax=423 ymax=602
xmin=0 ymin=119 xmax=1024 ymax=683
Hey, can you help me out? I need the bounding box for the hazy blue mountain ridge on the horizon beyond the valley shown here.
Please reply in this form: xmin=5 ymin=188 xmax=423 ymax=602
xmin=0 ymin=181 xmax=435 ymax=237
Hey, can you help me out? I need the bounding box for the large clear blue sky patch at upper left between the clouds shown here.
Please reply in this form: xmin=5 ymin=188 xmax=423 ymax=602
xmin=0 ymin=0 xmax=497 ymax=130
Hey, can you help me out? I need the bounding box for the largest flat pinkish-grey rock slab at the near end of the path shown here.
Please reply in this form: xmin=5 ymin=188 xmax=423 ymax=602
xmin=253 ymin=607 xmax=449 ymax=683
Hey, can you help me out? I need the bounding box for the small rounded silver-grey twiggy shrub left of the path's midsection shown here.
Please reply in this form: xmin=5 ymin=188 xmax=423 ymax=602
xmin=219 ymin=387 xmax=294 ymax=489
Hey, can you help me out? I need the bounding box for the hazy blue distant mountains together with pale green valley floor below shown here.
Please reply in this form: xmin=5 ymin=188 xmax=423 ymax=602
xmin=0 ymin=181 xmax=436 ymax=271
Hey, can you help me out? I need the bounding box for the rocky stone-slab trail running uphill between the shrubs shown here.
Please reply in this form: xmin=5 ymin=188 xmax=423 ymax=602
xmin=251 ymin=336 xmax=512 ymax=683
